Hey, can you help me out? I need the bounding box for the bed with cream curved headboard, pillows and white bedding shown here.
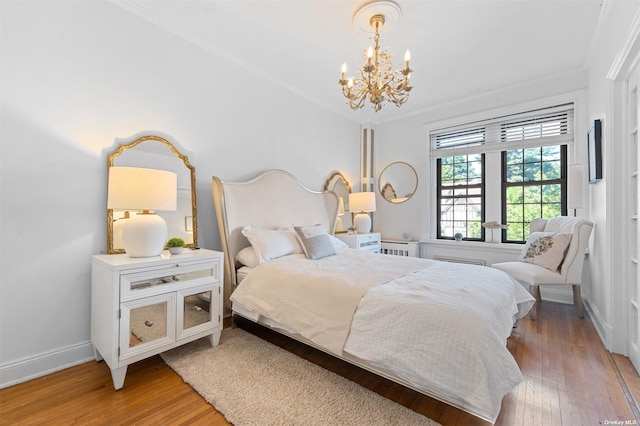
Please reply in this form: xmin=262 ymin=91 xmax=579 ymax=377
xmin=212 ymin=170 xmax=534 ymax=423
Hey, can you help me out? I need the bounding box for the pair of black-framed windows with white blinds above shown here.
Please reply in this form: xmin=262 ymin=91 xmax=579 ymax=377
xmin=430 ymin=104 xmax=573 ymax=243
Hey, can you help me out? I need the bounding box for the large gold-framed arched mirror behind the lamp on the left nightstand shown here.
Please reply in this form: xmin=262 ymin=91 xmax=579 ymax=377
xmin=107 ymin=135 xmax=198 ymax=254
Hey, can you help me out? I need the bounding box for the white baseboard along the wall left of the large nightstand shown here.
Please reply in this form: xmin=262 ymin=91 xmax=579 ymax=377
xmin=0 ymin=341 xmax=95 ymax=389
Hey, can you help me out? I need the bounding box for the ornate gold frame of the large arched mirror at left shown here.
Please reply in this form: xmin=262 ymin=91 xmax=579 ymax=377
xmin=107 ymin=135 xmax=198 ymax=254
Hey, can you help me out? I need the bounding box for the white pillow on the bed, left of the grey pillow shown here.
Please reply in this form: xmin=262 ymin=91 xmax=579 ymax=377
xmin=242 ymin=226 xmax=303 ymax=266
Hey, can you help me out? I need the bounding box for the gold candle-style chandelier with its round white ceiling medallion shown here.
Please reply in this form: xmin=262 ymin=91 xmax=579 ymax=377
xmin=339 ymin=1 xmax=412 ymax=112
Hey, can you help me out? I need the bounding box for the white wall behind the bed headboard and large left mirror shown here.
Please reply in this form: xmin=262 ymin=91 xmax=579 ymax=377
xmin=0 ymin=1 xmax=359 ymax=386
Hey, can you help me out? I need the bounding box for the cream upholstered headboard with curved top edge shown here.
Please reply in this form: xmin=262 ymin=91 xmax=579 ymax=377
xmin=212 ymin=170 xmax=338 ymax=306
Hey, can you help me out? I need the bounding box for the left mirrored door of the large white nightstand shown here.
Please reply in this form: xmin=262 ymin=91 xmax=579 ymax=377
xmin=120 ymin=294 xmax=175 ymax=359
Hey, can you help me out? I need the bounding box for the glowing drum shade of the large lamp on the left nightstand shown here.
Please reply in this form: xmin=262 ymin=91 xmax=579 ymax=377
xmin=107 ymin=167 xmax=178 ymax=210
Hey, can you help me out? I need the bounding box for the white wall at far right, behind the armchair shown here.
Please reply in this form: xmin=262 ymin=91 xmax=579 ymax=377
xmin=587 ymin=1 xmax=640 ymax=354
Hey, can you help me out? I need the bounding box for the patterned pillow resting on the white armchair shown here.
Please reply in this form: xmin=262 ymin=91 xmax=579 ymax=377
xmin=520 ymin=232 xmax=571 ymax=272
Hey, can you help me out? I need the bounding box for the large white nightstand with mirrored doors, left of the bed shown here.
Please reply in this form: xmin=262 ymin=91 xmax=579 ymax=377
xmin=91 ymin=249 xmax=223 ymax=389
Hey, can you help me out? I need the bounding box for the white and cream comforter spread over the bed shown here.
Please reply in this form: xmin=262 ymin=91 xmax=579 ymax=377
xmin=231 ymin=249 xmax=534 ymax=422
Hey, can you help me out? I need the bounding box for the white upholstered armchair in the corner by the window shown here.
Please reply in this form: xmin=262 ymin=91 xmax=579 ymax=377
xmin=491 ymin=216 xmax=593 ymax=320
